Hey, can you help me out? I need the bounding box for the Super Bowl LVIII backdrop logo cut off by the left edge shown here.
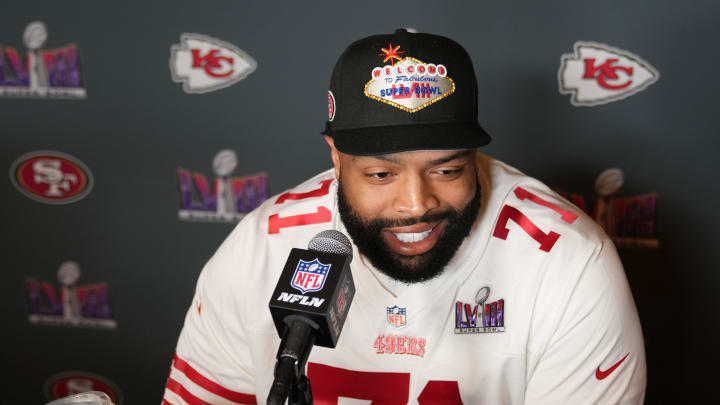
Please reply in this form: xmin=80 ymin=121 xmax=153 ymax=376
xmin=0 ymin=21 xmax=86 ymax=99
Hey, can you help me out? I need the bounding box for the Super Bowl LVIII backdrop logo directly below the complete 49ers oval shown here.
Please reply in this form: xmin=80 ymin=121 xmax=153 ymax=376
xmin=25 ymin=261 xmax=117 ymax=329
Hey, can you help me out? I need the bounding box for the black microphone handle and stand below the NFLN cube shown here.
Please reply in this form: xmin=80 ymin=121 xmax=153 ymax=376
xmin=267 ymin=315 xmax=319 ymax=405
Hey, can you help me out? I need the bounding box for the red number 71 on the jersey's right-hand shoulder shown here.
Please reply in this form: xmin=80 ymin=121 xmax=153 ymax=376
xmin=493 ymin=187 xmax=577 ymax=252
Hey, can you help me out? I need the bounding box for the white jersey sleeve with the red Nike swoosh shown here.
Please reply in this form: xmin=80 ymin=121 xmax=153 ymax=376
xmin=525 ymin=239 xmax=646 ymax=405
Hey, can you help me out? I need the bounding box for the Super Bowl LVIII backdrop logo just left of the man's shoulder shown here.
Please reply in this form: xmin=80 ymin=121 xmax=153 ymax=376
xmin=178 ymin=149 xmax=268 ymax=223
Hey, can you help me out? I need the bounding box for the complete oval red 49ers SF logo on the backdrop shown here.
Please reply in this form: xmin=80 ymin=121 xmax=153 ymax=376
xmin=10 ymin=151 xmax=93 ymax=204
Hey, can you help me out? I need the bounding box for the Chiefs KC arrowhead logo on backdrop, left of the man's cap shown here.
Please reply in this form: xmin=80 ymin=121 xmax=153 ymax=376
xmin=170 ymin=33 xmax=257 ymax=93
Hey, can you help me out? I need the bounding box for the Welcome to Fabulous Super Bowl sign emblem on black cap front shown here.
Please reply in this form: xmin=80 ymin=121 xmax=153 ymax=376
xmin=365 ymin=44 xmax=455 ymax=113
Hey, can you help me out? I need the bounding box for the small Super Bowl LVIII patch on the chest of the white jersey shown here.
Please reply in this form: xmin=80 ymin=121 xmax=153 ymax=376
xmin=455 ymin=287 xmax=505 ymax=334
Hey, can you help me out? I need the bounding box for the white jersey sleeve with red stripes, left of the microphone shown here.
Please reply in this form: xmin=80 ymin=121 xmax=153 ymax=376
xmin=163 ymin=229 xmax=257 ymax=405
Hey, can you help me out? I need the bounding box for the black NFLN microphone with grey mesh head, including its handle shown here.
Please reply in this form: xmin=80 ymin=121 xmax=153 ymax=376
xmin=267 ymin=230 xmax=355 ymax=405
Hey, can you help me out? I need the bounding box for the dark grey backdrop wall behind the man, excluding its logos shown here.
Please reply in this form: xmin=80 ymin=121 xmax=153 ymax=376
xmin=0 ymin=0 xmax=720 ymax=404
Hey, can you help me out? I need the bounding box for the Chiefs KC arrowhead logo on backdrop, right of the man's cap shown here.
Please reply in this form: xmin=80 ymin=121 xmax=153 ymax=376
xmin=558 ymin=42 xmax=660 ymax=106
